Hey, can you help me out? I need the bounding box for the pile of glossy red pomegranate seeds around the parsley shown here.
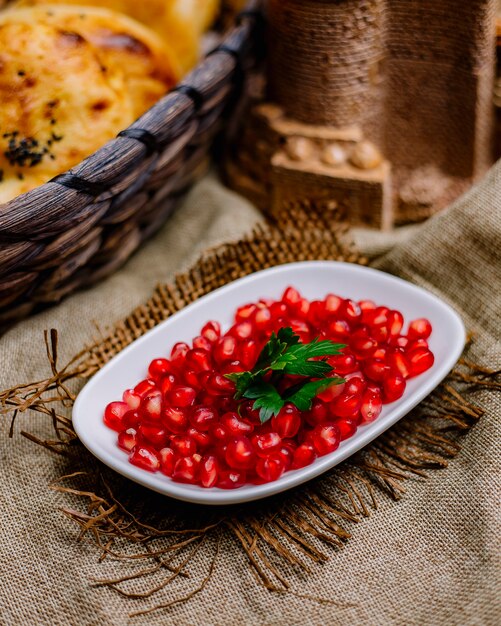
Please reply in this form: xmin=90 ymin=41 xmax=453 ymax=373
xmin=104 ymin=287 xmax=434 ymax=489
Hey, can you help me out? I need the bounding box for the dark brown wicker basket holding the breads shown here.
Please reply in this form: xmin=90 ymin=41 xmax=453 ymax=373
xmin=0 ymin=1 xmax=262 ymax=326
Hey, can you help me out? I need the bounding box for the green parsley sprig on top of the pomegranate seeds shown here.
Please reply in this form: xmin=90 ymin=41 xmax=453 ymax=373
xmin=226 ymin=327 xmax=346 ymax=423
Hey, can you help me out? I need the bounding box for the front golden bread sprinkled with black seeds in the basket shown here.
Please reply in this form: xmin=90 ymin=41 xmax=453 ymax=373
xmin=0 ymin=23 xmax=133 ymax=202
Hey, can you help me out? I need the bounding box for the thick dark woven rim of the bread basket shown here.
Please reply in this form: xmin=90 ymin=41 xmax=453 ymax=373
xmin=0 ymin=0 xmax=262 ymax=244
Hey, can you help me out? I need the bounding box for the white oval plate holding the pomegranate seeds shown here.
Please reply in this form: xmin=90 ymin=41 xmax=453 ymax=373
xmin=73 ymin=261 xmax=465 ymax=504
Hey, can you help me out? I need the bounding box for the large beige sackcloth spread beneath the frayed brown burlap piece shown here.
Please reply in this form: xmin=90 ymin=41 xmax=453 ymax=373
xmin=0 ymin=164 xmax=501 ymax=626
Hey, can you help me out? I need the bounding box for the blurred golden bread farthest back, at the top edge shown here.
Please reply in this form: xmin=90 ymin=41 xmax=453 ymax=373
xmin=11 ymin=0 xmax=220 ymax=71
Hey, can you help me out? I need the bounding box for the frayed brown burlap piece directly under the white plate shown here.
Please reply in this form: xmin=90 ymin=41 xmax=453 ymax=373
xmin=0 ymin=205 xmax=501 ymax=616
